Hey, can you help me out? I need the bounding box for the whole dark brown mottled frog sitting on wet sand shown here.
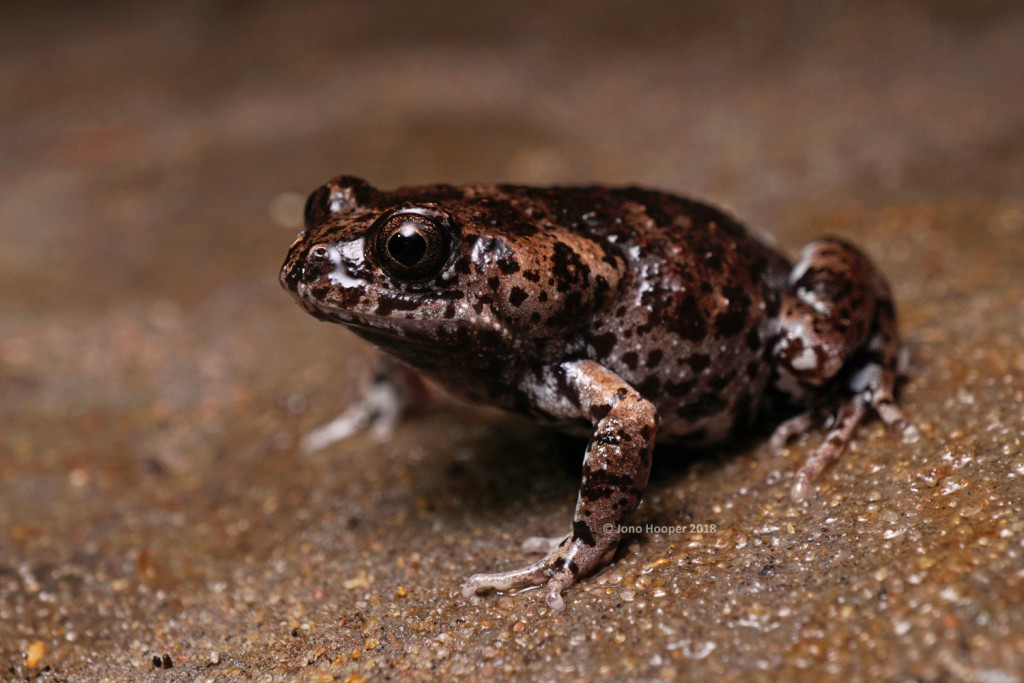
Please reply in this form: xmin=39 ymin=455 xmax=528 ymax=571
xmin=280 ymin=175 xmax=916 ymax=612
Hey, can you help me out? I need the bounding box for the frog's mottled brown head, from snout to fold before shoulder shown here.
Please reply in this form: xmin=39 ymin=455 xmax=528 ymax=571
xmin=281 ymin=176 xmax=618 ymax=367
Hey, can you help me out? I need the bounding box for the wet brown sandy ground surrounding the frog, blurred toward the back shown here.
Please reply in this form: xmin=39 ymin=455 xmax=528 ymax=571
xmin=0 ymin=1 xmax=1024 ymax=683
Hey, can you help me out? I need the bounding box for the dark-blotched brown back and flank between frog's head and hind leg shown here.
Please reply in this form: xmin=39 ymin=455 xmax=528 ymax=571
xmin=498 ymin=185 xmax=790 ymax=442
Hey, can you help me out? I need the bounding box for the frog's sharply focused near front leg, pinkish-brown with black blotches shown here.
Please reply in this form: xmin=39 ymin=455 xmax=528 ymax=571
xmin=463 ymin=360 xmax=660 ymax=611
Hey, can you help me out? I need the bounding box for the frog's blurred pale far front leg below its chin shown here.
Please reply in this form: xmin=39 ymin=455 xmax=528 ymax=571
xmin=299 ymin=355 xmax=426 ymax=454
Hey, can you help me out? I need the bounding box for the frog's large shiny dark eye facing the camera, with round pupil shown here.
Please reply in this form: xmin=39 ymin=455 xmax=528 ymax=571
xmin=371 ymin=209 xmax=455 ymax=282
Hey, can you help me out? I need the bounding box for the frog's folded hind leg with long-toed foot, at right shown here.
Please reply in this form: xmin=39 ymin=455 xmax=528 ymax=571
xmin=771 ymin=239 xmax=916 ymax=500
